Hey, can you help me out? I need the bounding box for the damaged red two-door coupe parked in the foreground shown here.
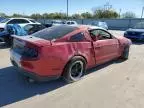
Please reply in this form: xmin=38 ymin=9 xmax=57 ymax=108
xmin=10 ymin=25 xmax=131 ymax=82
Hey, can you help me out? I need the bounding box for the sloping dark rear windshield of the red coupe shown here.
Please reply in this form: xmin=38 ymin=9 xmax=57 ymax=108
xmin=32 ymin=25 xmax=77 ymax=40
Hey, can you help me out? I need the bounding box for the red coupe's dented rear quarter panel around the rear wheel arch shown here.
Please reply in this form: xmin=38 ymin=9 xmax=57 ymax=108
xmin=37 ymin=42 xmax=95 ymax=75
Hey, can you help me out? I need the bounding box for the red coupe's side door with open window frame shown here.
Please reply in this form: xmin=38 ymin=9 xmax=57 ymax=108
xmin=90 ymin=29 xmax=119 ymax=64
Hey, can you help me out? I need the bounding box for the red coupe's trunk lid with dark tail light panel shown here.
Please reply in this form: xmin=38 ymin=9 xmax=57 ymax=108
xmin=11 ymin=36 xmax=51 ymax=59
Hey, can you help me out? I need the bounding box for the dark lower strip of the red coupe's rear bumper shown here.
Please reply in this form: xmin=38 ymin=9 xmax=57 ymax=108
xmin=11 ymin=60 xmax=60 ymax=82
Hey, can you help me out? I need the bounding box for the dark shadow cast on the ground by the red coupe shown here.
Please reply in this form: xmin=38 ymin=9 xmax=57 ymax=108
xmin=0 ymin=61 xmax=122 ymax=106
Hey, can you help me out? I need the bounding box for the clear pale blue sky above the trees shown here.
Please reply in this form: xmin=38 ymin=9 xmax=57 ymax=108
xmin=0 ymin=0 xmax=144 ymax=17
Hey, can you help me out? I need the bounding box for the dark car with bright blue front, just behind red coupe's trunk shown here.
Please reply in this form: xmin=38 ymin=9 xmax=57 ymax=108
xmin=0 ymin=24 xmax=46 ymax=45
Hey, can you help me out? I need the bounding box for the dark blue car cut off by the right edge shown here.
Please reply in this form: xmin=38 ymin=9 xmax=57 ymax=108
xmin=124 ymin=22 xmax=144 ymax=40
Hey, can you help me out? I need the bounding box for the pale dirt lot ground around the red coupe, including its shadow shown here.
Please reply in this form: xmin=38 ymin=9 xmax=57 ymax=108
xmin=0 ymin=31 xmax=144 ymax=108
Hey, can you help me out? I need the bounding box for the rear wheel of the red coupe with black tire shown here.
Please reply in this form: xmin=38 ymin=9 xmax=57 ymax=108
xmin=63 ymin=56 xmax=86 ymax=83
